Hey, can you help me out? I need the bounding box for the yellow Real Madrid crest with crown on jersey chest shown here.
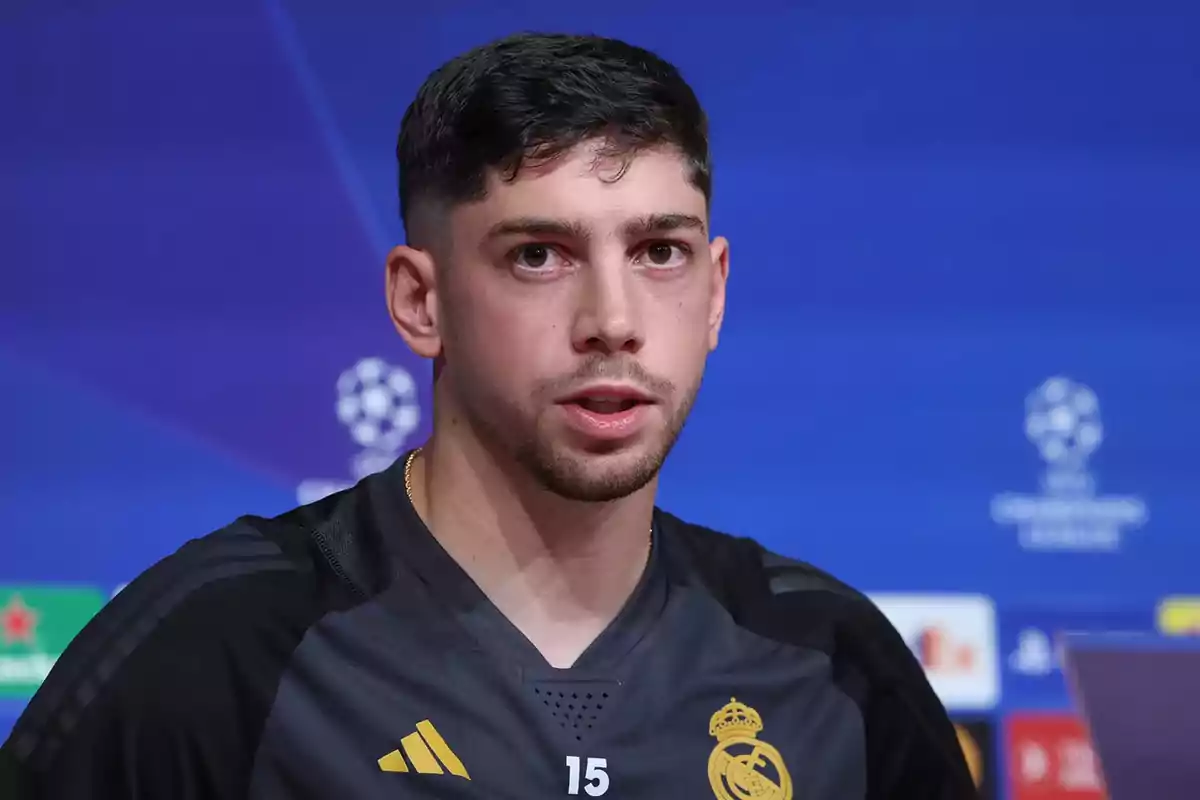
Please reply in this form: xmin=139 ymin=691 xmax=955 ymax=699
xmin=708 ymin=698 xmax=792 ymax=800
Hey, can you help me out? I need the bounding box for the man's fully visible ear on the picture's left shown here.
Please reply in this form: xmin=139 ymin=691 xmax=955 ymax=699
xmin=388 ymin=245 xmax=442 ymax=359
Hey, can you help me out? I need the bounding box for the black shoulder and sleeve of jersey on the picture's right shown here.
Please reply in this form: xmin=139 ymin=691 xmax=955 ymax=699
xmin=660 ymin=515 xmax=977 ymax=800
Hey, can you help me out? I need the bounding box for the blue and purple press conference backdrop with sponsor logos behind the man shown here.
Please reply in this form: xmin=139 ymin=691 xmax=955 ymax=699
xmin=0 ymin=0 xmax=1200 ymax=798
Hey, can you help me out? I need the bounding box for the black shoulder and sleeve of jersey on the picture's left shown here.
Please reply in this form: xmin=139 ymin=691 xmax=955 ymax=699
xmin=5 ymin=491 xmax=384 ymax=780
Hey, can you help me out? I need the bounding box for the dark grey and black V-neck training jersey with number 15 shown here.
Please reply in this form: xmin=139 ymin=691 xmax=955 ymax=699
xmin=0 ymin=461 xmax=974 ymax=800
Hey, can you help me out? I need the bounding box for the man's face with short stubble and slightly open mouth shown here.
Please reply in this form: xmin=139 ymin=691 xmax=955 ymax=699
xmin=437 ymin=144 xmax=728 ymax=501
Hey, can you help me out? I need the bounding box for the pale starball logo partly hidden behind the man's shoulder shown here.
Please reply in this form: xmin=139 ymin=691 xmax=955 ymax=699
xmin=298 ymin=357 xmax=421 ymax=504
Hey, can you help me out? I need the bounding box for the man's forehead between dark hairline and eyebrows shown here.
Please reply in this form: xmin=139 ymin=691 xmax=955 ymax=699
xmin=455 ymin=143 xmax=707 ymax=236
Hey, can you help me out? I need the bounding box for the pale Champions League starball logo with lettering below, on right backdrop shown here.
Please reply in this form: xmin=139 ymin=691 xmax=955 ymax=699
xmin=991 ymin=377 xmax=1147 ymax=552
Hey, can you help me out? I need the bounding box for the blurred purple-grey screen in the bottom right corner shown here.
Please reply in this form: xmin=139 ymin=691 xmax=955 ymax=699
xmin=1063 ymin=633 xmax=1200 ymax=800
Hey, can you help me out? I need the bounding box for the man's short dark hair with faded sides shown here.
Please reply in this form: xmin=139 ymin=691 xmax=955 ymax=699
xmin=396 ymin=34 xmax=712 ymax=235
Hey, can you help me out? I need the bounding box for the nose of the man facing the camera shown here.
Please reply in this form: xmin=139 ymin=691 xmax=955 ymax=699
xmin=571 ymin=259 xmax=643 ymax=355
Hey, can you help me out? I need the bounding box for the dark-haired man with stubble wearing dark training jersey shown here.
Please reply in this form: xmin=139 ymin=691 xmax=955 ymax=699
xmin=4 ymin=35 xmax=973 ymax=800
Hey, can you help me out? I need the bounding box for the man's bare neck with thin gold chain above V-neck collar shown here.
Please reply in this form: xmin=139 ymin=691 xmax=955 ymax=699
xmin=412 ymin=426 xmax=656 ymax=667
